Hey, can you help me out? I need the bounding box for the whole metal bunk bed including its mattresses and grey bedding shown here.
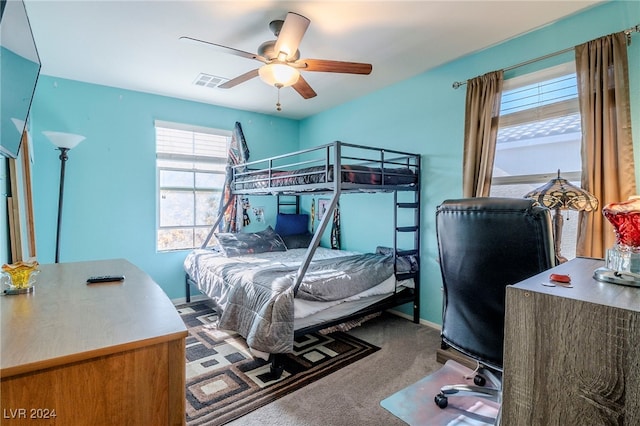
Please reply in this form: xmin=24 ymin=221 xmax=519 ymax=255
xmin=185 ymin=141 xmax=420 ymax=375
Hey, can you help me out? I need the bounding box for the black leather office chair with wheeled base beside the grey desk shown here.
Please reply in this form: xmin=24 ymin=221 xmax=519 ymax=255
xmin=435 ymin=197 xmax=556 ymax=408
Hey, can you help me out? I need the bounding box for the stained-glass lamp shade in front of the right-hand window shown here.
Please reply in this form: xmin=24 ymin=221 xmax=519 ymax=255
xmin=524 ymin=170 xmax=598 ymax=212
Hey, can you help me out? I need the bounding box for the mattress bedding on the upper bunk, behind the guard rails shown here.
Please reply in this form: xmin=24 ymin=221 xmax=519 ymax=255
xmin=234 ymin=165 xmax=417 ymax=190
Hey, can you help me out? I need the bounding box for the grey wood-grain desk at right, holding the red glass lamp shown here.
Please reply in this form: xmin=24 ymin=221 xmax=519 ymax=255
xmin=502 ymin=258 xmax=640 ymax=426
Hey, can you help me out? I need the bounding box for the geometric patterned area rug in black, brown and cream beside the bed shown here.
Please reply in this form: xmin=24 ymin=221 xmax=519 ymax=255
xmin=176 ymin=301 xmax=379 ymax=426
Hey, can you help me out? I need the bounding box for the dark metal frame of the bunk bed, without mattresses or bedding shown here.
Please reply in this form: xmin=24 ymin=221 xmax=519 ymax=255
xmin=186 ymin=141 xmax=420 ymax=368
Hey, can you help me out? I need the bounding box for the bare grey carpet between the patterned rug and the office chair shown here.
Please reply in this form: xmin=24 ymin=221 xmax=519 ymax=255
xmin=228 ymin=314 xmax=442 ymax=426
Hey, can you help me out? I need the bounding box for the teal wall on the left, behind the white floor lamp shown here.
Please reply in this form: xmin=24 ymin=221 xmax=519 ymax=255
xmin=31 ymin=76 xmax=299 ymax=298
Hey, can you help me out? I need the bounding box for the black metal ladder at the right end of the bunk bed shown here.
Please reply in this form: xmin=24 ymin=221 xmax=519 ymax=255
xmin=393 ymin=187 xmax=420 ymax=324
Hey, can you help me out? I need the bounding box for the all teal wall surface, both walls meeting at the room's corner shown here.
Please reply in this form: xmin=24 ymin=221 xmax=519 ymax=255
xmin=16 ymin=1 xmax=640 ymax=323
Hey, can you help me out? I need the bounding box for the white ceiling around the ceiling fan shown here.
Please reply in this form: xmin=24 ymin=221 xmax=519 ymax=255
xmin=24 ymin=0 xmax=599 ymax=119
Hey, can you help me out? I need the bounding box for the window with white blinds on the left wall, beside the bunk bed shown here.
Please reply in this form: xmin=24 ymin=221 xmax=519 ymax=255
xmin=155 ymin=121 xmax=231 ymax=251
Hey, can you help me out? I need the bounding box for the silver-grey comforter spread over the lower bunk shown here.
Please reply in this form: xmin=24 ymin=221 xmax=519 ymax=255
xmin=185 ymin=247 xmax=395 ymax=353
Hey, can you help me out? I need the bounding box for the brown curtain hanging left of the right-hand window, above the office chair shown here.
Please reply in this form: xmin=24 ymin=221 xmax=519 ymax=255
xmin=462 ymin=70 xmax=504 ymax=197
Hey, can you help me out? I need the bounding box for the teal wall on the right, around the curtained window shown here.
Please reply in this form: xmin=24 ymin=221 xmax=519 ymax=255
xmin=300 ymin=1 xmax=640 ymax=323
